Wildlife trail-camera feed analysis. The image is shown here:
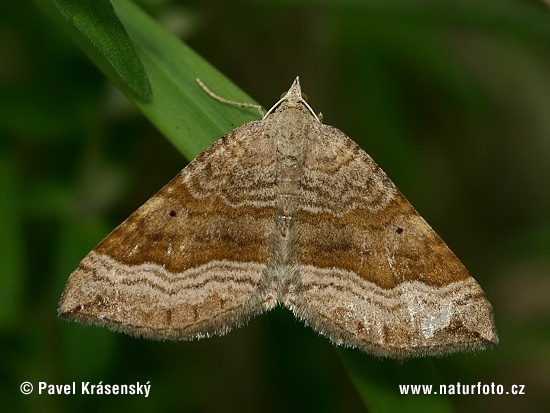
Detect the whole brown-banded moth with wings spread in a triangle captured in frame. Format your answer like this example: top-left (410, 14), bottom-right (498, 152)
top-left (59, 78), bottom-right (498, 358)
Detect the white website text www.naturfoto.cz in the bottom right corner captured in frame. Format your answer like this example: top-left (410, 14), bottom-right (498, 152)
top-left (399, 382), bottom-right (525, 395)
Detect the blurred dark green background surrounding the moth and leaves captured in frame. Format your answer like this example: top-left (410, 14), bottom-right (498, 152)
top-left (0, 0), bottom-right (550, 412)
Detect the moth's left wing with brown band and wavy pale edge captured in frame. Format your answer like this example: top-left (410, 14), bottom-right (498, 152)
top-left (59, 123), bottom-right (282, 339)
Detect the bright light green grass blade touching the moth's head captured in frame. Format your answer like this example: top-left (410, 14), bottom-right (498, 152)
top-left (112, 0), bottom-right (259, 159)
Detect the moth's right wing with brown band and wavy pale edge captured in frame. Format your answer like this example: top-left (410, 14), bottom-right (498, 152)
top-left (286, 126), bottom-right (497, 358)
